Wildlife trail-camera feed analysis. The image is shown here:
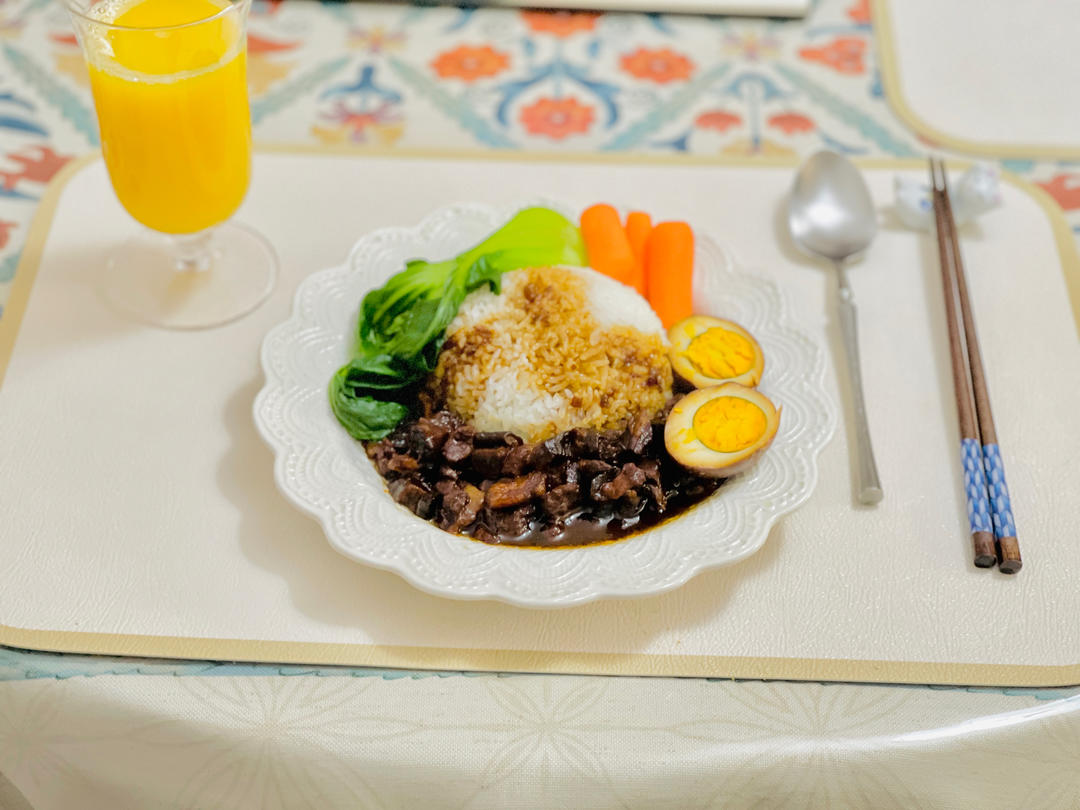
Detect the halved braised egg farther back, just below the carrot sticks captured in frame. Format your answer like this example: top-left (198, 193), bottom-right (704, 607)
top-left (667, 315), bottom-right (765, 388)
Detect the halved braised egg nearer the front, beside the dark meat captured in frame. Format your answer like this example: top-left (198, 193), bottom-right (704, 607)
top-left (664, 382), bottom-right (780, 478)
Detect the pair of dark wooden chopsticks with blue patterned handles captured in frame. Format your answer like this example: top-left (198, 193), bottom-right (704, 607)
top-left (930, 159), bottom-right (1023, 573)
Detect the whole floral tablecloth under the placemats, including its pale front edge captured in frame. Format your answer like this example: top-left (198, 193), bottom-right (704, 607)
top-left (0, 0), bottom-right (1080, 810)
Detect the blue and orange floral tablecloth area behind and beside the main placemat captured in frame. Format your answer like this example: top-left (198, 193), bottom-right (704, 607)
top-left (0, 0), bottom-right (1080, 306)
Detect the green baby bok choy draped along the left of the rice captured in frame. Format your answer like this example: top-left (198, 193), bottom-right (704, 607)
top-left (329, 207), bottom-right (585, 441)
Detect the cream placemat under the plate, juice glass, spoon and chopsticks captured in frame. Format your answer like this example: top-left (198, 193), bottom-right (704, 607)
top-left (0, 154), bottom-right (1080, 684)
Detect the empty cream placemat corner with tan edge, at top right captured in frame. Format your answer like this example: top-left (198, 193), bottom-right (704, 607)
top-left (874, 0), bottom-right (1080, 159)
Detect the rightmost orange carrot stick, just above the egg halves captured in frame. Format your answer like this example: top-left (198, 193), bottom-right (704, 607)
top-left (645, 222), bottom-right (693, 328)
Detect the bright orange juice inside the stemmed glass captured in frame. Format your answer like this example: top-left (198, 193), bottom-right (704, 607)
top-left (84, 0), bottom-right (252, 233)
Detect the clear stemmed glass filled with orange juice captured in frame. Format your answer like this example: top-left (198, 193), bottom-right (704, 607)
top-left (67, 0), bottom-right (278, 329)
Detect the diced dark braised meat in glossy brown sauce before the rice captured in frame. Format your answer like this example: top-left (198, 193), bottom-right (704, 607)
top-left (366, 410), bottom-right (723, 548)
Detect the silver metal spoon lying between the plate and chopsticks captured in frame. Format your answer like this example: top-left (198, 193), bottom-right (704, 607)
top-left (787, 151), bottom-right (882, 503)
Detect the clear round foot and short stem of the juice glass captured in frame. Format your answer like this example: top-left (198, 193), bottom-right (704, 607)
top-left (102, 222), bottom-right (278, 329)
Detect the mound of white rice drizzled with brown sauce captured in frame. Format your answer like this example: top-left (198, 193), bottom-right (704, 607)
top-left (428, 267), bottom-right (672, 442)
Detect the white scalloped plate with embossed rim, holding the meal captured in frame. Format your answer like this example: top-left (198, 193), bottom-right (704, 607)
top-left (255, 201), bottom-right (836, 607)
